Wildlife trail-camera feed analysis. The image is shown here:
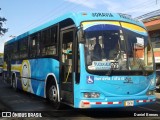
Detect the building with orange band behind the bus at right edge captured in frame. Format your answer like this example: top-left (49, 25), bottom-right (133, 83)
top-left (136, 9), bottom-right (160, 91)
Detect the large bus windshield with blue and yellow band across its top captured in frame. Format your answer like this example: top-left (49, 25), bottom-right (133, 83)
top-left (82, 21), bottom-right (153, 71)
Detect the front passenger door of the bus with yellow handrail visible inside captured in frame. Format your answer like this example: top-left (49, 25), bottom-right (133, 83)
top-left (60, 28), bottom-right (75, 104)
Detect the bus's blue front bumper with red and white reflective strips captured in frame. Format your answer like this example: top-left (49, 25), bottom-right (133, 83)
top-left (77, 95), bottom-right (156, 108)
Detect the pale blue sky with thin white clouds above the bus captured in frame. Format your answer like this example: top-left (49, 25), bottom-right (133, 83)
top-left (0, 0), bottom-right (160, 52)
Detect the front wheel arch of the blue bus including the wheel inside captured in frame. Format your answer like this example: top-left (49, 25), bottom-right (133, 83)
top-left (45, 75), bottom-right (61, 109)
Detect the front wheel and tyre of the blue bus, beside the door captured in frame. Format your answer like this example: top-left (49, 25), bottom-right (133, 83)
top-left (47, 80), bottom-right (62, 110)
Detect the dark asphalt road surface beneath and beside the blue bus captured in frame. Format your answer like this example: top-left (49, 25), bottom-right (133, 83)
top-left (0, 78), bottom-right (160, 120)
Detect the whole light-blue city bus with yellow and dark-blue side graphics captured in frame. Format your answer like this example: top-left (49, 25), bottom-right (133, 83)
top-left (3, 12), bottom-right (156, 109)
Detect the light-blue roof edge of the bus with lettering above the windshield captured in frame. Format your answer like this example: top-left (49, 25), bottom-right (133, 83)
top-left (5, 12), bottom-right (145, 45)
